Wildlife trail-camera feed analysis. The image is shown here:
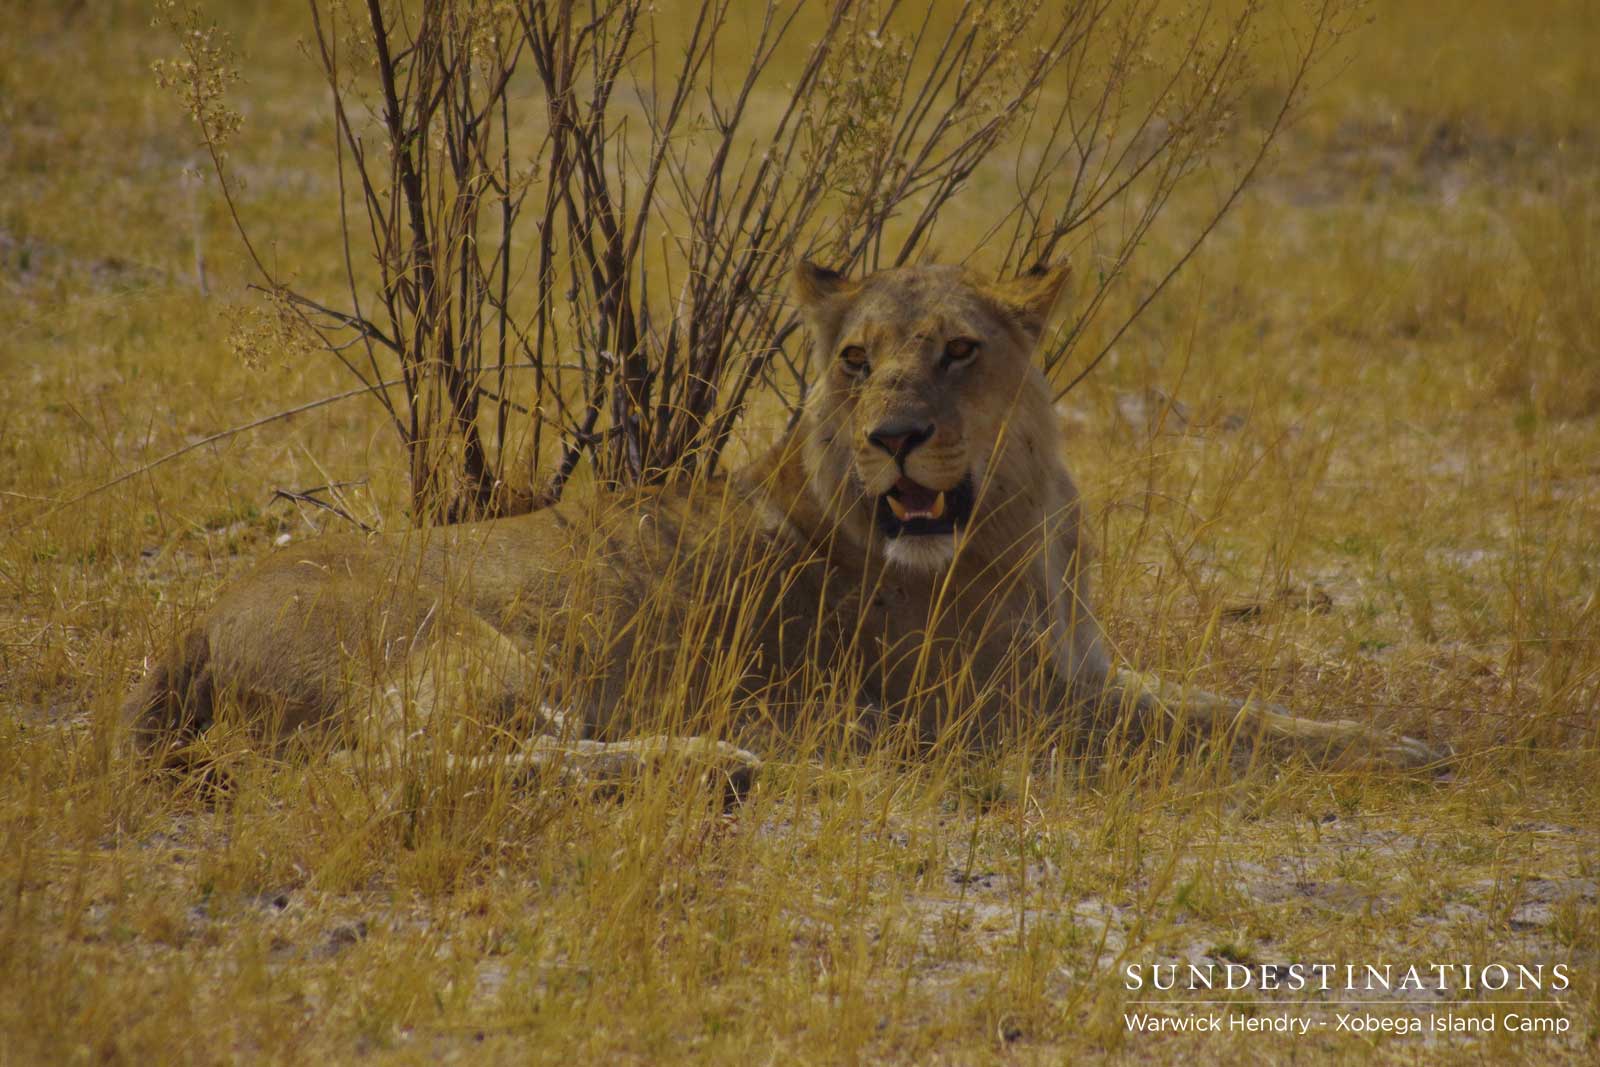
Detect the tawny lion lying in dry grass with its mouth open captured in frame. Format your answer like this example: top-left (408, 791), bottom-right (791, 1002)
top-left (126, 262), bottom-right (1437, 790)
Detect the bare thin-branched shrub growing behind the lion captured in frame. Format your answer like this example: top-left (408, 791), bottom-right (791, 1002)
top-left (158, 0), bottom-right (1352, 522)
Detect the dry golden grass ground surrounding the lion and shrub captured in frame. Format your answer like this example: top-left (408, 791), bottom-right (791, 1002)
top-left (0, 0), bottom-right (1600, 1064)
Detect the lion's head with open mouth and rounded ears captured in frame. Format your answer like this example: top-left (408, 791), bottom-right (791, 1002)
top-left (795, 262), bottom-right (1072, 571)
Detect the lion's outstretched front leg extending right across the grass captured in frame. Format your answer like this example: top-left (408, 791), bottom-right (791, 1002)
top-left (1115, 669), bottom-right (1450, 769)
